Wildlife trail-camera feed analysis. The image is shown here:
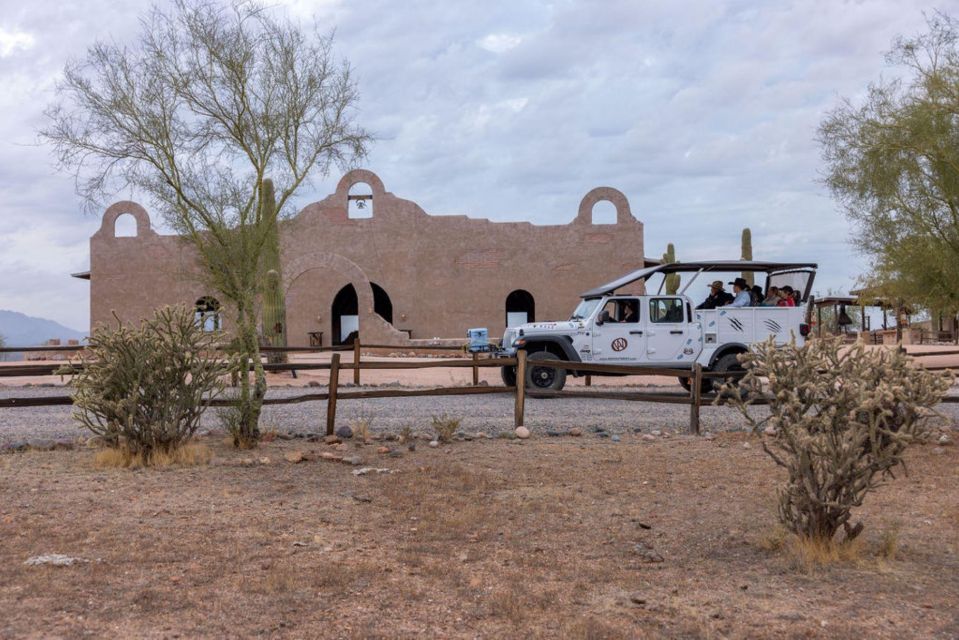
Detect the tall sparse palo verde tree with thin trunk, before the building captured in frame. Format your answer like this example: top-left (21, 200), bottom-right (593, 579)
top-left (41, 0), bottom-right (370, 447)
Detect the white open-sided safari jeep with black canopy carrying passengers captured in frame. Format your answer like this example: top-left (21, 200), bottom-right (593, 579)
top-left (500, 261), bottom-right (816, 391)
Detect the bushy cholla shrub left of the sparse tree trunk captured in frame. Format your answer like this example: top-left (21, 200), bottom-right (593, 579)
top-left (66, 307), bottom-right (229, 466)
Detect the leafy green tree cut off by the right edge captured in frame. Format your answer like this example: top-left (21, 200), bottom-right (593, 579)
top-left (819, 13), bottom-right (959, 322)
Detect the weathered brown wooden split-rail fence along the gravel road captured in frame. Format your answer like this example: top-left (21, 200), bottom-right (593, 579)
top-left (0, 340), bottom-right (959, 434)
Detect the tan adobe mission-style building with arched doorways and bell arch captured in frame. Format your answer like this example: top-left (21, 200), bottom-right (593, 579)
top-left (75, 169), bottom-right (650, 346)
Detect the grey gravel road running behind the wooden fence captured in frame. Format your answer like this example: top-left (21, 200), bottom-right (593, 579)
top-left (0, 387), bottom-right (959, 446)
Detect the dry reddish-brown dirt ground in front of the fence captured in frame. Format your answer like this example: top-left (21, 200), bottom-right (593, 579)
top-left (0, 434), bottom-right (959, 638)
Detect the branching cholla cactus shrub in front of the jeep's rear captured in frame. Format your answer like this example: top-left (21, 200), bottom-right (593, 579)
top-left (724, 338), bottom-right (952, 542)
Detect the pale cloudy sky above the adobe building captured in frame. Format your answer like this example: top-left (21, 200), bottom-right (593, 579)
top-left (0, 0), bottom-right (959, 329)
